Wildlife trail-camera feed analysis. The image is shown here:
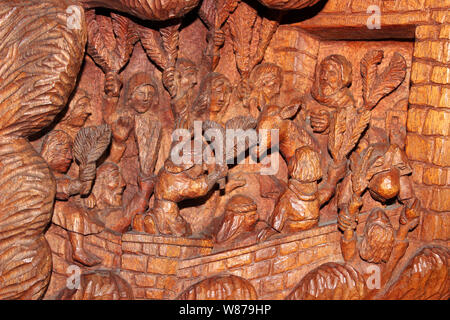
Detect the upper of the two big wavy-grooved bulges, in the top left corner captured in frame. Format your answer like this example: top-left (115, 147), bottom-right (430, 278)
top-left (0, 1), bottom-right (86, 137)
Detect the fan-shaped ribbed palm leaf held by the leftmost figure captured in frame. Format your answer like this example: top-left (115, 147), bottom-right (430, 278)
top-left (73, 124), bottom-right (111, 165)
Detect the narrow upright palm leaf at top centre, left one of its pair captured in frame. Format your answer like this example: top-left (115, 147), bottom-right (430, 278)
top-left (227, 3), bottom-right (257, 77)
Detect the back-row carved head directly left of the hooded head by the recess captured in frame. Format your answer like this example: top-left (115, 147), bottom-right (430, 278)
top-left (250, 63), bottom-right (283, 105)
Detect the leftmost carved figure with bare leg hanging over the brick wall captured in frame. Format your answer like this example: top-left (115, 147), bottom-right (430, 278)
top-left (41, 130), bottom-right (103, 266)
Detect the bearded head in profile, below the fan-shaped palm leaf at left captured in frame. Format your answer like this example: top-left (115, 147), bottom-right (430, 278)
top-left (92, 162), bottom-right (126, 209)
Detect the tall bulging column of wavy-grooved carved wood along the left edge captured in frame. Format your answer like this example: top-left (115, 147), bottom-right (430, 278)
top-left (0, 0), bottom-right (86, 299)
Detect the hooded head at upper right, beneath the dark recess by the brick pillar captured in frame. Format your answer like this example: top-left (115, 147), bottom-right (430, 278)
top-left (315, 54), bottom-right (352, 96)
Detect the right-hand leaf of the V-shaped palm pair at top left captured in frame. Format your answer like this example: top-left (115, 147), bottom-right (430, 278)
top-left (111, 13), bottom-right (139, 69)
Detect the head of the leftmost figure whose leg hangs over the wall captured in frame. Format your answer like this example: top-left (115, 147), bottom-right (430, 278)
top-left (41, 130), bottom-right (73, 170)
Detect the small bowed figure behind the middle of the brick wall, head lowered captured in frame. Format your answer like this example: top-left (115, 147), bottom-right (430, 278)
top-left (214, 195), bottom-right (267, 249)
